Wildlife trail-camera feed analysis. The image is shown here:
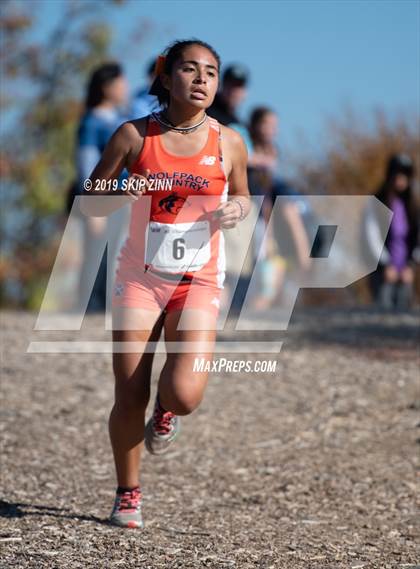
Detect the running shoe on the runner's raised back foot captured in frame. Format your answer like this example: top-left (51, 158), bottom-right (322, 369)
top-left (144, 398), bottom-right (181, 454)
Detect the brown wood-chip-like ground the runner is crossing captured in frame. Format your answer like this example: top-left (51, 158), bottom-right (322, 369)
top-left (0, 307), bottom-right (420, 569)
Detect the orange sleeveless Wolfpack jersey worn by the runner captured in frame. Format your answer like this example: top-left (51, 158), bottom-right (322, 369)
top-left (119, 114), bottom-right (228, 288)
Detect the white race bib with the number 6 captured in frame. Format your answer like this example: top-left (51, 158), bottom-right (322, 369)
top-left (144, 221), bottom-right (210, 273)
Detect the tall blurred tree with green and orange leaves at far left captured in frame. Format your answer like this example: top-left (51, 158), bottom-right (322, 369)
top-left (0, 0), bottom-right (150, 308)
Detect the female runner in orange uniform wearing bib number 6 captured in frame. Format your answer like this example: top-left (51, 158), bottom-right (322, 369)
top-left (81, 40), bottom-right (250, 527)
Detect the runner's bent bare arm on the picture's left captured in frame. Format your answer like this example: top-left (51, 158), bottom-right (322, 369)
top-left (80, 122), bottom-right (148, 217)
